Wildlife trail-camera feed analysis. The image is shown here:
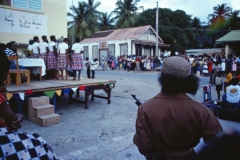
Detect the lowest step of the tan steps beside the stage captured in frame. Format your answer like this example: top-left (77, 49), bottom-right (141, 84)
top-left (37, 113), bottom-right (60, 126)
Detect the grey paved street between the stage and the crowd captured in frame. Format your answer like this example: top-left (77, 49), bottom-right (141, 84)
top-left (17, 70), bottom-right (240, 160)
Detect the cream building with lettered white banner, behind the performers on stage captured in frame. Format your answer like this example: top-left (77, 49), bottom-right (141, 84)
top-left (0, 0), bottom-right (67, 45)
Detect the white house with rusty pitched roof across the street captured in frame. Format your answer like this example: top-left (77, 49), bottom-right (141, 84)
top-left (80, 25), bottom-right (170, 63)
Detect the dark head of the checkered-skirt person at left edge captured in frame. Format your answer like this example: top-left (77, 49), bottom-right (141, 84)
top-left (0, 45), bottom-right (10, 86)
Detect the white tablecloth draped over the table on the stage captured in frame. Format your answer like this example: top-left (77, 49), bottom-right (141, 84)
top-left (18, 58), bottom-right (46, 76)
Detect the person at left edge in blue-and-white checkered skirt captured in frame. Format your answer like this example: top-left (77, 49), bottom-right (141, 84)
top-left (0, 44), bottom-right (57, 160)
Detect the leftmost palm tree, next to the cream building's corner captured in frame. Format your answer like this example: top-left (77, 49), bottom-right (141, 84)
top-left (67, 0), bottom-right (101, 39)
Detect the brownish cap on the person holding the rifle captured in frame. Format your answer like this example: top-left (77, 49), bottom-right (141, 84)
top-left (161, 56), bottom-right (191, 77)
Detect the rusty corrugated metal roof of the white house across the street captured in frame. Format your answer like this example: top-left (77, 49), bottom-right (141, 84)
top-left (80, 25), bottom-right (162, 43)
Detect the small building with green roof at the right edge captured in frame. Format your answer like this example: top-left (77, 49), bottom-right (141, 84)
top-left (216, 30), bottom-right (240, 57)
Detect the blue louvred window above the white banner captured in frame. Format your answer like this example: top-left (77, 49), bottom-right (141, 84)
top-left (12, 0), bottom-right (42, 11)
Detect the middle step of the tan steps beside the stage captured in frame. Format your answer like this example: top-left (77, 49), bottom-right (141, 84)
top-left (34, 104), bottom-right (54, 117)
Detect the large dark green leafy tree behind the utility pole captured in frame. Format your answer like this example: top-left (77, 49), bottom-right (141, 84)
top-left (136, 8), bottom-right (201, 52)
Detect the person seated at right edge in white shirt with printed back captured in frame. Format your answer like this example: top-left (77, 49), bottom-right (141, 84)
top-left (222, 78), bottom-right (240, 107)
